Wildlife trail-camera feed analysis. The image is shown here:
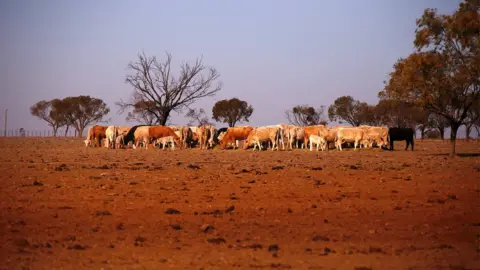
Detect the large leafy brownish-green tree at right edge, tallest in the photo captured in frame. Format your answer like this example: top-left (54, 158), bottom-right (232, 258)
top-left (379, 0), bottom-right (480, 155)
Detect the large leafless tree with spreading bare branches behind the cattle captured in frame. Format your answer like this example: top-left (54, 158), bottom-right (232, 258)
top-left (116, 53), bottom-right (222, 125)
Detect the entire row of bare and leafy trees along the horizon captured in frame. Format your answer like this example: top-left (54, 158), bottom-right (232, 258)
top-left (31, 0), bottom-right (480, 154)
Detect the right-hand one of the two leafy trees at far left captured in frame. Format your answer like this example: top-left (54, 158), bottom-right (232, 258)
top-left (61, 96), bottom-right (110, 137)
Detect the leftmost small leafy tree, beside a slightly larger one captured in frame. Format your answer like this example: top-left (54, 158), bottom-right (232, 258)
top-left (30, 99), bottom-right (66, 136)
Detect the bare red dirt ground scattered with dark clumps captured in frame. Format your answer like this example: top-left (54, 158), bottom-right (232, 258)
top-left (0, 138), bottom-right (480, 269)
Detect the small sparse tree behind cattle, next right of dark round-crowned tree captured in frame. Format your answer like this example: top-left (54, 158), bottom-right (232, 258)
top-left (285, 105), bottom-right (328, 126)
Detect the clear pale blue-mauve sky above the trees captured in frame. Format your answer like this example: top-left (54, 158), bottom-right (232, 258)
top-left (0, 0), bottom-right (460, 136)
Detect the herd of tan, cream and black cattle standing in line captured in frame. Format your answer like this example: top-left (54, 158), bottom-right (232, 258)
top-left (84, 124), bottom-right (414, 151)
